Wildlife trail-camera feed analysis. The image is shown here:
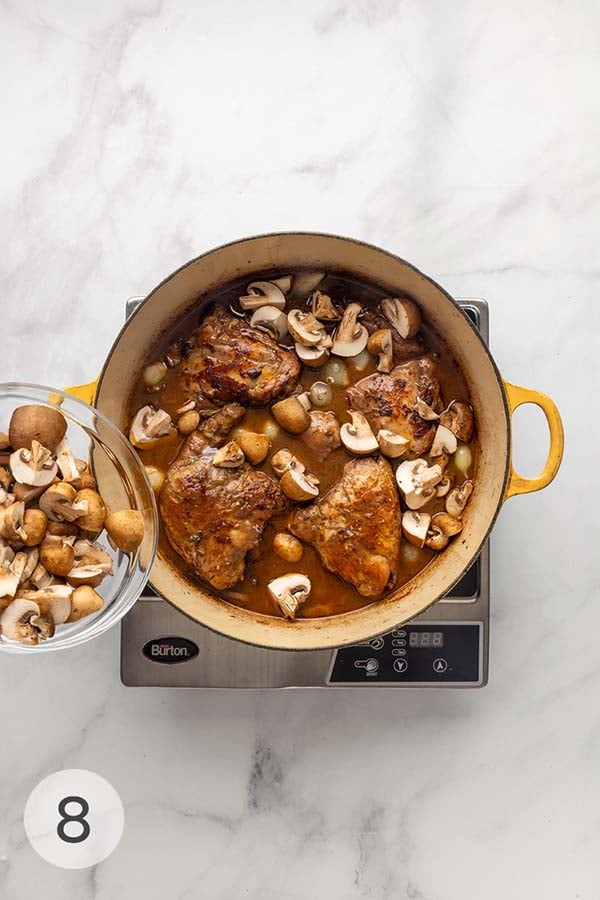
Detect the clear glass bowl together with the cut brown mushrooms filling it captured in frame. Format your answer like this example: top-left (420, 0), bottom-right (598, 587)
top-left (0, 382), bottom-right (158, 653)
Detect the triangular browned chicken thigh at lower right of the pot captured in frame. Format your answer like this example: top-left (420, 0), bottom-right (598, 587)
top-left (289, 457), bottom-right (402, 597)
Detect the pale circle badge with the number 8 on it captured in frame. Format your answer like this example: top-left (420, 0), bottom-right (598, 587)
top-left (23, 769), bottom-right (125, 869)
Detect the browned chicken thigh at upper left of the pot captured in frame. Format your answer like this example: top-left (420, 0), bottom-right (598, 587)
top-left (183, 306), bottom-right (301, 406)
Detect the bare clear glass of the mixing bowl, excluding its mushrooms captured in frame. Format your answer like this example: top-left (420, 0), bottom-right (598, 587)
top-left (0, 382), bottom-right (158, 653)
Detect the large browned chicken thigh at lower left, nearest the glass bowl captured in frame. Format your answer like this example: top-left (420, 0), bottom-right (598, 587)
top-left (160, 403), bottom-right (285, 590)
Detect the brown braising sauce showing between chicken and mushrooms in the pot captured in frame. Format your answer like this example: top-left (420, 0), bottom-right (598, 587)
top-left (130, 273), bottom-right (477, 618)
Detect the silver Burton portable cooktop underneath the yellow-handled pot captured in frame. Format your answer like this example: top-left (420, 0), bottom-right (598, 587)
top-left (121, 298), bottom-right (490, 688)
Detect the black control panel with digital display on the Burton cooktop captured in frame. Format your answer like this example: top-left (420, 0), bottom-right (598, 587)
top-left (326, 622), bottom-right (483, 687)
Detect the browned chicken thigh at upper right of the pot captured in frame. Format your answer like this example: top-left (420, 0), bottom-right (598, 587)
top-left (346, 356), bottom-right (442, 456)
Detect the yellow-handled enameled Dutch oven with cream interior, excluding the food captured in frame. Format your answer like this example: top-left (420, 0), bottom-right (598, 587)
top-left (71, 233), bottom-right (564, 650)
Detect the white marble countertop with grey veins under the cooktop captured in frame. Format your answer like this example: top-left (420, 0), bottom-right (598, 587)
top-left (0, 0), bottom-right (600, 900)
